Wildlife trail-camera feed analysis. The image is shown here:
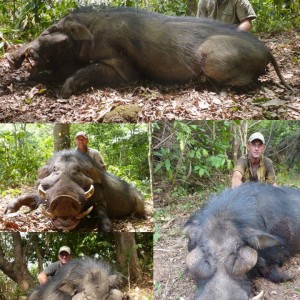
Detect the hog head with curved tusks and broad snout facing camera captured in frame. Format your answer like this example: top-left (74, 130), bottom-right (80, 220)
top-left (38, 152), bottom-right (101, 231)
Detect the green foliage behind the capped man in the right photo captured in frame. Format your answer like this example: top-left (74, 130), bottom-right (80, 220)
top-left (154, 120), bottom-right (300, 197)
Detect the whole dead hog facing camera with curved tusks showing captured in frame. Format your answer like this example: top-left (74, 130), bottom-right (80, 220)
top-left (5, 150), bottom-right (145, 231)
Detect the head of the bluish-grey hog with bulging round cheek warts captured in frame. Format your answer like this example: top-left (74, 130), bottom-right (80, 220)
top-left (186, 219), bottom-right (258, 300)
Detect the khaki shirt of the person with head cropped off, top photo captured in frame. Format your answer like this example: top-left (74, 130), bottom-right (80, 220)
top-left (197, 0), bottom-right (256, 24)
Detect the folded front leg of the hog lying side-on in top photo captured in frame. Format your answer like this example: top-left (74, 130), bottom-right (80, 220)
top-left (62, 59), bottom-right (138, 98)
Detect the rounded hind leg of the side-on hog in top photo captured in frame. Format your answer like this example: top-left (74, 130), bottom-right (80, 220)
top-left (197, 35), bottom-right (269, 86)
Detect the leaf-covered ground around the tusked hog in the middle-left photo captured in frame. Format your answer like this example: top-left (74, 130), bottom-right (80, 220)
top-left (0, 187), bottom-right (153, 232)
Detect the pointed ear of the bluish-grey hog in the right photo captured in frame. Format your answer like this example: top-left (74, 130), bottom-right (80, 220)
top-left (244, 228), bottom-right (284, 249)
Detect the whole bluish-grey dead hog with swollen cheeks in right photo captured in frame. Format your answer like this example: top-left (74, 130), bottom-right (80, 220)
top-left (185, 183), bottom-right (300, 300)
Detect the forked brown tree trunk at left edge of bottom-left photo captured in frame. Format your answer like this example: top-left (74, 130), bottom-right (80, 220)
top-left (0, 232), bottom-right (34, 291)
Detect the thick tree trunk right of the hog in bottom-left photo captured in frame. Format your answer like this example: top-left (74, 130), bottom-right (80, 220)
top-left (113, 232), bottom-right (141, 282)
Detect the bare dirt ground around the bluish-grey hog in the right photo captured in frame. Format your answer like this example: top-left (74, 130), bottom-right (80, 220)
top-left (154, 196), bottom-right (300, 300)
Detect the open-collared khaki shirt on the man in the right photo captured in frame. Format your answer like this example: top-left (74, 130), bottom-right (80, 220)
top-left (233, 155), bottom-right (275, 184)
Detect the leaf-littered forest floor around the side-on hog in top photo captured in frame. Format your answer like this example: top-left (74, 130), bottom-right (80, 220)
top-left (0, 30), bottom-right (300, 123)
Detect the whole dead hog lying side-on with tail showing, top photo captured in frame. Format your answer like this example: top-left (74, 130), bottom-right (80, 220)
top-left (7, 7), bottom-right (291, 98)
